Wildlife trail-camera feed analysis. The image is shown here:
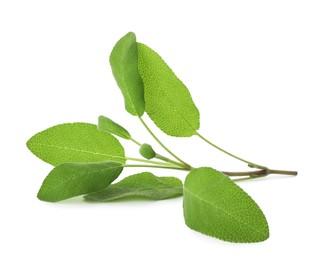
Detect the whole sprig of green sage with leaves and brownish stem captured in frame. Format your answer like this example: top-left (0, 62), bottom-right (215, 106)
top-left (27, 32), bottom-right (297, 243)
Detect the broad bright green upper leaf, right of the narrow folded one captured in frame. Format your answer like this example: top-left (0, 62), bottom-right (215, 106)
top-left (138, 43), bottom-right (200, 137)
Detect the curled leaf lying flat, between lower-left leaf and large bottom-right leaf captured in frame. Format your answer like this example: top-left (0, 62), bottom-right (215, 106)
top-left (84, 172), bottom-right (183, 201)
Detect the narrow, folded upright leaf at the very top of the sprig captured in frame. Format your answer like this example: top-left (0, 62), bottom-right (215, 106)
top-left (110, 32), bottom-right (145, 116)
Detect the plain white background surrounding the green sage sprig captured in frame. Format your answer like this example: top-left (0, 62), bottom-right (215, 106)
top-left (0, 0), bottom-right (323, 260)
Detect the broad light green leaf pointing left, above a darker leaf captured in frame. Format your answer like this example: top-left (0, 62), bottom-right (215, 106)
top-left (27, 123), bottom-right (125, 165)
